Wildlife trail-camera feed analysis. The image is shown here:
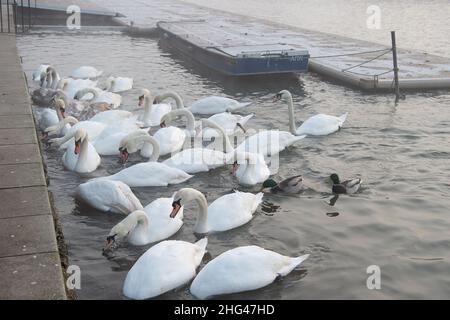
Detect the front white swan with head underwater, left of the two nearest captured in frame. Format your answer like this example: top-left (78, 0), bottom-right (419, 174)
top-left (123, 238), bottom-right (208, 299)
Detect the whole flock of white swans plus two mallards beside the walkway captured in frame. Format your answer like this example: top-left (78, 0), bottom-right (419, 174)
top-left (32, 65), bottom-right (361, 299)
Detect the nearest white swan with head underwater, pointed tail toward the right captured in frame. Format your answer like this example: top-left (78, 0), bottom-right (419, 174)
top-left (190, 246), bottom-right (309, 299)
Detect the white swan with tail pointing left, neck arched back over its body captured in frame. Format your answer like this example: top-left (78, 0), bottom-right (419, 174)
top-left (96, 134), bottom-right (192, 187)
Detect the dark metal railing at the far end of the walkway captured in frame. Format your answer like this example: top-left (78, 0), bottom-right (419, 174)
top-left (0, 0), bottom-right (32, 33)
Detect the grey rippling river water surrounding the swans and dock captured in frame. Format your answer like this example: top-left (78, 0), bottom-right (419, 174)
top-left (17, 0), bottom-right (450, 299)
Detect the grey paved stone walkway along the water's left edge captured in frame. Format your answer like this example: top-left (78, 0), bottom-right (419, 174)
top-left (0, 34), bottom-right (66, 299)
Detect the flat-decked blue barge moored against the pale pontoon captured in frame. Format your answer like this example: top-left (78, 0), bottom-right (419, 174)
top-left (157, 21), bottom-right (309, 76)
